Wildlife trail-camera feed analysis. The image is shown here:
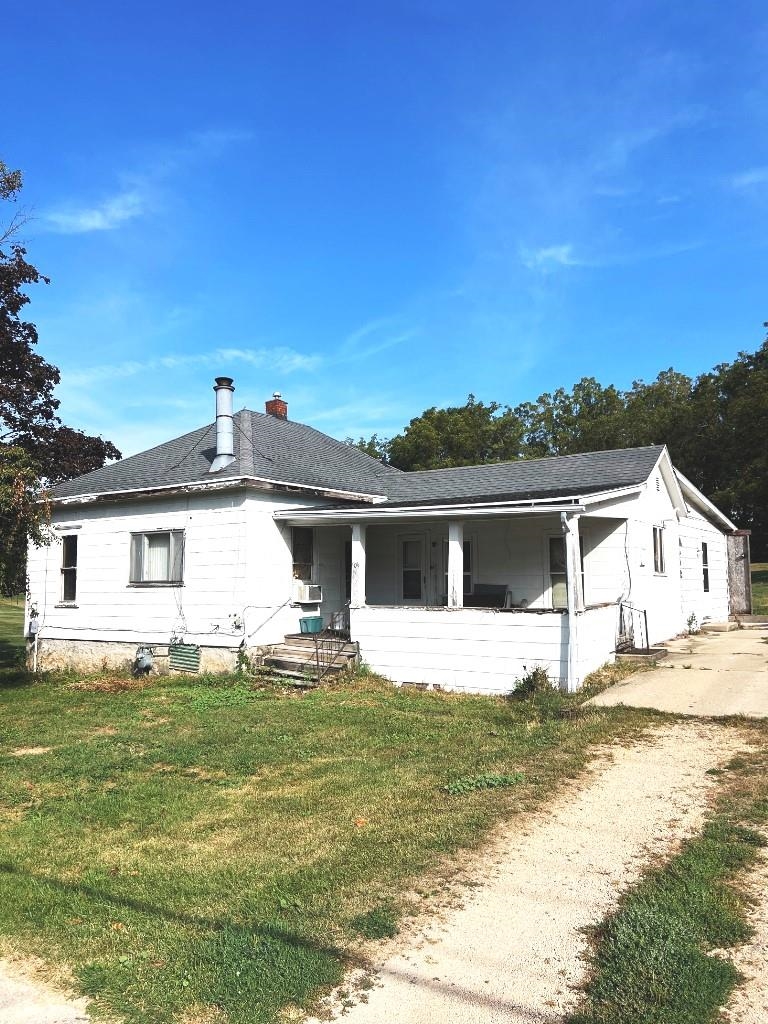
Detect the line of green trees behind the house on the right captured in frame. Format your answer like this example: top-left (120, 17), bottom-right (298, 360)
top-left (348, 344), bottom-right (768, 561)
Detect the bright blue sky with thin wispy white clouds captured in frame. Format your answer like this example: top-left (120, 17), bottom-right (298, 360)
top-left (6, 0), bottom-right (768, 454)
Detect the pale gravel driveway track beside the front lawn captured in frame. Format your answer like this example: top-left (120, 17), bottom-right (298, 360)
top-left (313, 722), bottom-right (749, 1024)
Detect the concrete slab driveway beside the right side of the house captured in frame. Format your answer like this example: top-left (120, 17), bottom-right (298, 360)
top-left (588, 629), bottom-right (768, 718)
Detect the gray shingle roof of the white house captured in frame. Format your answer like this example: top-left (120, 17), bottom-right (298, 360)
top-left (53, 410), bottom-right (664, 507)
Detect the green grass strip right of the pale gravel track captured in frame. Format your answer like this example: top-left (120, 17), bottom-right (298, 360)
top-left (567, 728), bottom-right (768, 1024)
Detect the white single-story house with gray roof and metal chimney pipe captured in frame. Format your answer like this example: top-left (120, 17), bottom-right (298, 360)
top-left (27, 377), bottom-right (736, 693)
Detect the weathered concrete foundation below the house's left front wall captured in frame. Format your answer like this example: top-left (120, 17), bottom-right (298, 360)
top-left (27, 639), bottom-right (241, 676)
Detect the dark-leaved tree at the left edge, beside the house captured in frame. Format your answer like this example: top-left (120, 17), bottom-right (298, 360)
top-left (0, 161), bottom-right (120, 592)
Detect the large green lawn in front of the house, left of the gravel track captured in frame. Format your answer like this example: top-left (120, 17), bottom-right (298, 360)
top-left (0, 651), bottom-right (652, 1024)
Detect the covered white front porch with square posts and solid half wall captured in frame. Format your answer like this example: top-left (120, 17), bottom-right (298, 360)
top-left (276, 504), bottom-right (621, 693)
